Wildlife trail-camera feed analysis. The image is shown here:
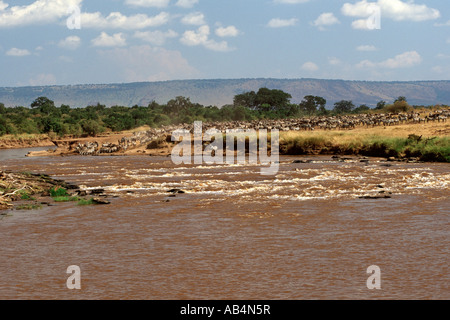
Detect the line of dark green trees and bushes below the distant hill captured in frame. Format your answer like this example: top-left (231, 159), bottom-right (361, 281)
top-left (0, 88), bottom-right (442, 137)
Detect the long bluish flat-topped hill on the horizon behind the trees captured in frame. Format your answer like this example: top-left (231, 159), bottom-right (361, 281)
top-left (0, 78), bottom-right (450, 108)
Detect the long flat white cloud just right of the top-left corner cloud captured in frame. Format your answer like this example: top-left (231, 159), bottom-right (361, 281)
top-left (81, 12), bottom-right (169, 30)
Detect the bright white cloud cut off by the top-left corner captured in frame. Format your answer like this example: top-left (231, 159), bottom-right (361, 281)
top-left (0, 0), bottom-right (83, 28)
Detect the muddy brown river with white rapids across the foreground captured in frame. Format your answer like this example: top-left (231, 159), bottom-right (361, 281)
top-left (0, 151), bottom-right (450, 300)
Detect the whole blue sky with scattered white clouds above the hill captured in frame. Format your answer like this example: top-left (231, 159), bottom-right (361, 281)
top-left (0, 0), bottom-right (450, 86)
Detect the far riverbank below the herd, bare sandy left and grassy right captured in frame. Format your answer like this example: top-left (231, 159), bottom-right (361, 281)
top-left (13, 122), bottom-right (450, 162)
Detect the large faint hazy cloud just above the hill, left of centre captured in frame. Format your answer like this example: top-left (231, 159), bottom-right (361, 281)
top-left (99, 45), bottom-right (199, 82)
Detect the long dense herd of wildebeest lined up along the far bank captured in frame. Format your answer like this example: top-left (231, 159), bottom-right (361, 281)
top-left (72, 108), bottom-right (450, 156)
